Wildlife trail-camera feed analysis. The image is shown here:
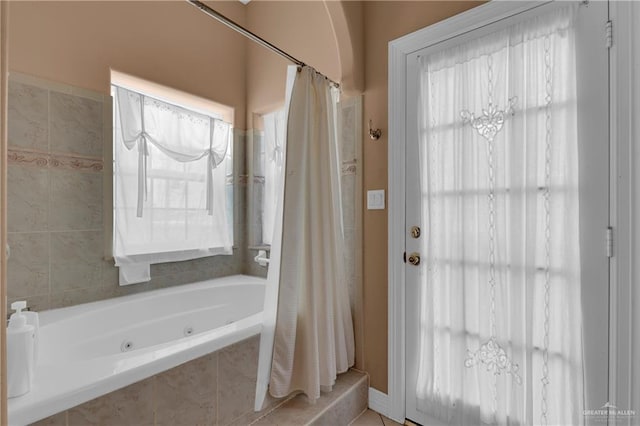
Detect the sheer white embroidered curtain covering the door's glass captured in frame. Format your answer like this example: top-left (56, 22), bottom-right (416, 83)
top-left (417, 7), bottom-right (582, 425)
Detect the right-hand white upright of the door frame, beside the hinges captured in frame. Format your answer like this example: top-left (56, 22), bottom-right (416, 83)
top-left (609, 1), bottom-right (640, 425)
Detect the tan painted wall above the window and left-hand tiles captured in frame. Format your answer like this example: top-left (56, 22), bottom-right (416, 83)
top-left (9, 1), bottom-right (246, 129)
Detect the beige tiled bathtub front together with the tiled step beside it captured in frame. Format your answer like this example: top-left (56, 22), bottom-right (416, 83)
top-left (33, 342), bottom-right (368, 426)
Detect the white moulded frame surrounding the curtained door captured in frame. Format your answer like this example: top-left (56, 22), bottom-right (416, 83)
top-left (384, 1), bottom-right (640, 423)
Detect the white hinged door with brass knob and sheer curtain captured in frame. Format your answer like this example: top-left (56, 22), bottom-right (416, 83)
top-left (405, 2), bottom-right (610, 425)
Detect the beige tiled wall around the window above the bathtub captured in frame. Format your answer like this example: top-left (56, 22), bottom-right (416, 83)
top-left (7, 73), bottom-right (247, 311)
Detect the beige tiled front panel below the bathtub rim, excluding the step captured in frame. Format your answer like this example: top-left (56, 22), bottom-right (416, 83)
top-left (34, 336), bottom-right (278, 426)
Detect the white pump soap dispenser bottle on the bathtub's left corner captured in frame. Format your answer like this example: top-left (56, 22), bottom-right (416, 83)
top-left (7, 301), bottom-right (35, 398)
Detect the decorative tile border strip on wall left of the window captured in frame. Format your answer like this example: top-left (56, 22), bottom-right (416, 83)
top-left (7, 148), bottom-right (104, 172)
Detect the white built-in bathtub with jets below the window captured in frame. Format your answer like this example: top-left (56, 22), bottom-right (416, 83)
top-left (8, 275), bottom-right (265, 425)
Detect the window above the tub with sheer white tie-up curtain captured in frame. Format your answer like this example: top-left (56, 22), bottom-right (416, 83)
top-left (112, 75), bottom-right (233, 285)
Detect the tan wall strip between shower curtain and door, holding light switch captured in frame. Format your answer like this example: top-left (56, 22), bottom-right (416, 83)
top-left (363, 1), bottom-right (480, 392)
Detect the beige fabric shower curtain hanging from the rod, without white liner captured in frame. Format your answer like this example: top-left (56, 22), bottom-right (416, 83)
top-left (269, 67), bottom-right (354, 401)
